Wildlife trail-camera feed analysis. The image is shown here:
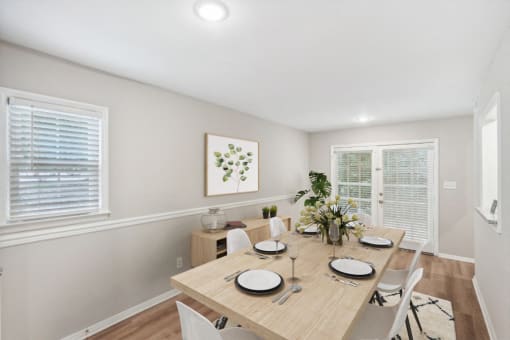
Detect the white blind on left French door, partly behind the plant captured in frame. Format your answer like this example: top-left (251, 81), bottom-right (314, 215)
top-left (336, 151), bottom-right (372, 216)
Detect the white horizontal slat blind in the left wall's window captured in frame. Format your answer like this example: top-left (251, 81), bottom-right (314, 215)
top-left (7, 97), bottom-right (102, 221)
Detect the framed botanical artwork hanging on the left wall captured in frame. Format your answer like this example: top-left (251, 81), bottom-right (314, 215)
top-left (205, 133), bottom-right (259, 196)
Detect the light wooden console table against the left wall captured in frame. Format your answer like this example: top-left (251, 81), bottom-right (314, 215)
top-left (191, 216), bottom-right (291, 267)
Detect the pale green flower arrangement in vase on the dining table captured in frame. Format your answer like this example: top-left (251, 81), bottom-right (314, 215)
top-left (296, 195), bottom-right (363, 245)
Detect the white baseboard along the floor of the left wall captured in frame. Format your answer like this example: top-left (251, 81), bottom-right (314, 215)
top-left (61, 289), bottom-right (180, 340)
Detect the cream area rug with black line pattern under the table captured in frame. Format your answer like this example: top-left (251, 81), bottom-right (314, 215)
top-left (383, 292), bottom-right (455, 340)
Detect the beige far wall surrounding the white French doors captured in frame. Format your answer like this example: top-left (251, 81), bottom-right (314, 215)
top-left (309, 116), bottom-right (473, 258)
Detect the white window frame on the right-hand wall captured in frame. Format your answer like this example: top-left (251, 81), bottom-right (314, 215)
top-left (475, 92), bottom-right (503, 234)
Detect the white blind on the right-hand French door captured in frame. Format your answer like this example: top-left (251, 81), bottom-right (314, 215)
top-left (383, 147), bottom-right (434, 241)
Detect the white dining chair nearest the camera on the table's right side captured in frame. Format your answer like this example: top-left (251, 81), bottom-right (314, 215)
top-left (351, 268), bottom-right (423, 340)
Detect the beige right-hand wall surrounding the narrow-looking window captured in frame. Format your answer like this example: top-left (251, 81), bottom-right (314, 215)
top-left (474, 30), bottom-right (510, 339)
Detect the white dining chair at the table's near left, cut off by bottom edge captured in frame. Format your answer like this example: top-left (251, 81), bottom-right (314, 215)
top-left (176, 301), bottom-right (262, 340)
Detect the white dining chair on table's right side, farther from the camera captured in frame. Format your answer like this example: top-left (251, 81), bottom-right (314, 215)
top-left (376, 242), bottom-right (426, 332)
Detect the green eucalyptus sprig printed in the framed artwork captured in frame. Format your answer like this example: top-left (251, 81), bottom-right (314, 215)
top-left (214, 144), bottom-right (253, 192)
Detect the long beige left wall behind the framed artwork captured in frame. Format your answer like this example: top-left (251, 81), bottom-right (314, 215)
top-left (0, 43), bottom-right (308, 340)
